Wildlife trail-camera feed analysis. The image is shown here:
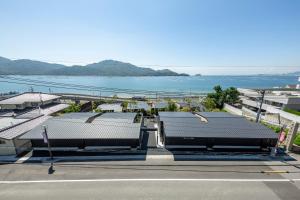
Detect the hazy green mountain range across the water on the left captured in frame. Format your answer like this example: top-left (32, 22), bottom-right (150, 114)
top-left (0, 57), bottom-right (189, 76)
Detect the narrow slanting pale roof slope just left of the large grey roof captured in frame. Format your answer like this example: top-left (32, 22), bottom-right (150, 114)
top-left (0, 116), bottom-right (51, 140)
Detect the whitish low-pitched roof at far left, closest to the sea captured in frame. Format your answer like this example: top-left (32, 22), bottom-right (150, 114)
top-left (0, 93), bottom-right (60, 105)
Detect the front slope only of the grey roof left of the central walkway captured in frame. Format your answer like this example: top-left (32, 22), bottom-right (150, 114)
top-left (21, 118), bottom-right (140, 139)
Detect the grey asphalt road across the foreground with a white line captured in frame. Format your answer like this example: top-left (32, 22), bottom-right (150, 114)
top-left (0, 161), bottom-right (300, 200)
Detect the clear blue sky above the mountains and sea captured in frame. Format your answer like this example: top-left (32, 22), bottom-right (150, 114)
top-left (0, 0), bottom-right (300, 74)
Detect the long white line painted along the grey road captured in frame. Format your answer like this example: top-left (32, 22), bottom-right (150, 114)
top-left (0, 178), bottom-right (300, 184)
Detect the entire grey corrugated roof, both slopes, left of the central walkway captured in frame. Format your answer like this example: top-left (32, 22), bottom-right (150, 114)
top-left (21, 113), bottom-right (141, 140)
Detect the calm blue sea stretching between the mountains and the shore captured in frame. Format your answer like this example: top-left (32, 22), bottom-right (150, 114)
top-left (0, 76), bottom-right (298, 95)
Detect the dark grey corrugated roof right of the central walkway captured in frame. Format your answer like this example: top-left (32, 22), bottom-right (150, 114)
top-left (159, 112), bottom-right (277, 138)
